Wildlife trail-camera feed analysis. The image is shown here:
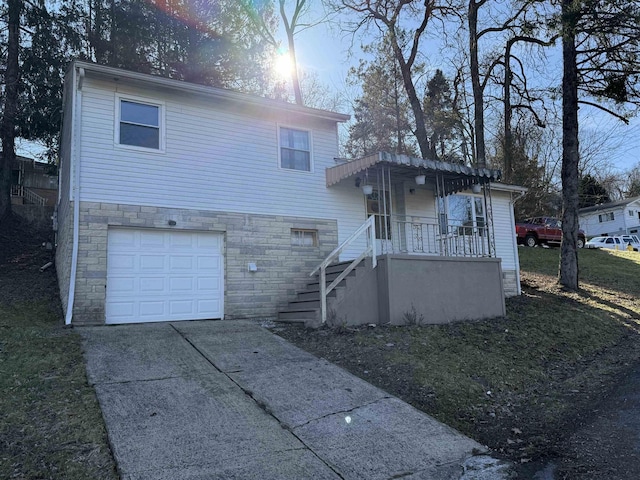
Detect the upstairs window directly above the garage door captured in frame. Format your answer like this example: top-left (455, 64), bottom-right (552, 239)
top-left (118, 99), bottom-right (160, 150)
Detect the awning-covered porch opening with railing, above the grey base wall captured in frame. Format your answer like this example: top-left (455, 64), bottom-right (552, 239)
top-left (326, 153), bottom-right (500, 258)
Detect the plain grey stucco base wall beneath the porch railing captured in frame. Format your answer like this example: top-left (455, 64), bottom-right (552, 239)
top-left (377, 255), bottom-right (505, 325)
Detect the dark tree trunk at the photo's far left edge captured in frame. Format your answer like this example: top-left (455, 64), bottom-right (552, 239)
top-left (0, 0), bottom-right (23, 220)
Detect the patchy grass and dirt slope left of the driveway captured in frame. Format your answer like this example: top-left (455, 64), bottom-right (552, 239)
top-left (0, 216), bottom-right (117, 480)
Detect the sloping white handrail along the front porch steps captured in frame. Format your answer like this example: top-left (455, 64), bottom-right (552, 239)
top-left (309, 216), bottom-right (378, 323)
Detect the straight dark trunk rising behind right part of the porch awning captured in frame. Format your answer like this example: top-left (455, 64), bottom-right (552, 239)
top-left (468, 0), bottom-right (487, 168)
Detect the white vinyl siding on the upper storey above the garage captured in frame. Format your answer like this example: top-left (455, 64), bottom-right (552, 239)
top-left (75, 77), bottom-right (365, 258)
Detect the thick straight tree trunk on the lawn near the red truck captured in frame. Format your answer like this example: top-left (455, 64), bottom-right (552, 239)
top-left (558, 0), bottom-right (578, 290)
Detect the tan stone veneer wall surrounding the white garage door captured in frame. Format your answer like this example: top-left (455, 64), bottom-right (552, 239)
top-left (69, 202), bottom-right (338, 325)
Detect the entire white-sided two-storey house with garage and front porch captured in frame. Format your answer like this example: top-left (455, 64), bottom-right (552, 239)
top-left (56, 62), bottom-right (523, 324)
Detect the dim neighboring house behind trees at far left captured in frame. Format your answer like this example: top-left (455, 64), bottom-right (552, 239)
top-left (5, 153), bottom-right (58, 206)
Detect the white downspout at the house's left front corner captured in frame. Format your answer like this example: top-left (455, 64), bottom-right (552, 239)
top-left (64, 68), bottom-right (84, 326)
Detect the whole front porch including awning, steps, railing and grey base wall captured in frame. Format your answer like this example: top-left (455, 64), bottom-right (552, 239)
top-left (279, 153), bottom-right (505, 326)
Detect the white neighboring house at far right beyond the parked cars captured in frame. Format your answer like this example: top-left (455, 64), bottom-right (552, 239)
top-left (578, 197), bottom-right (640, 237)
